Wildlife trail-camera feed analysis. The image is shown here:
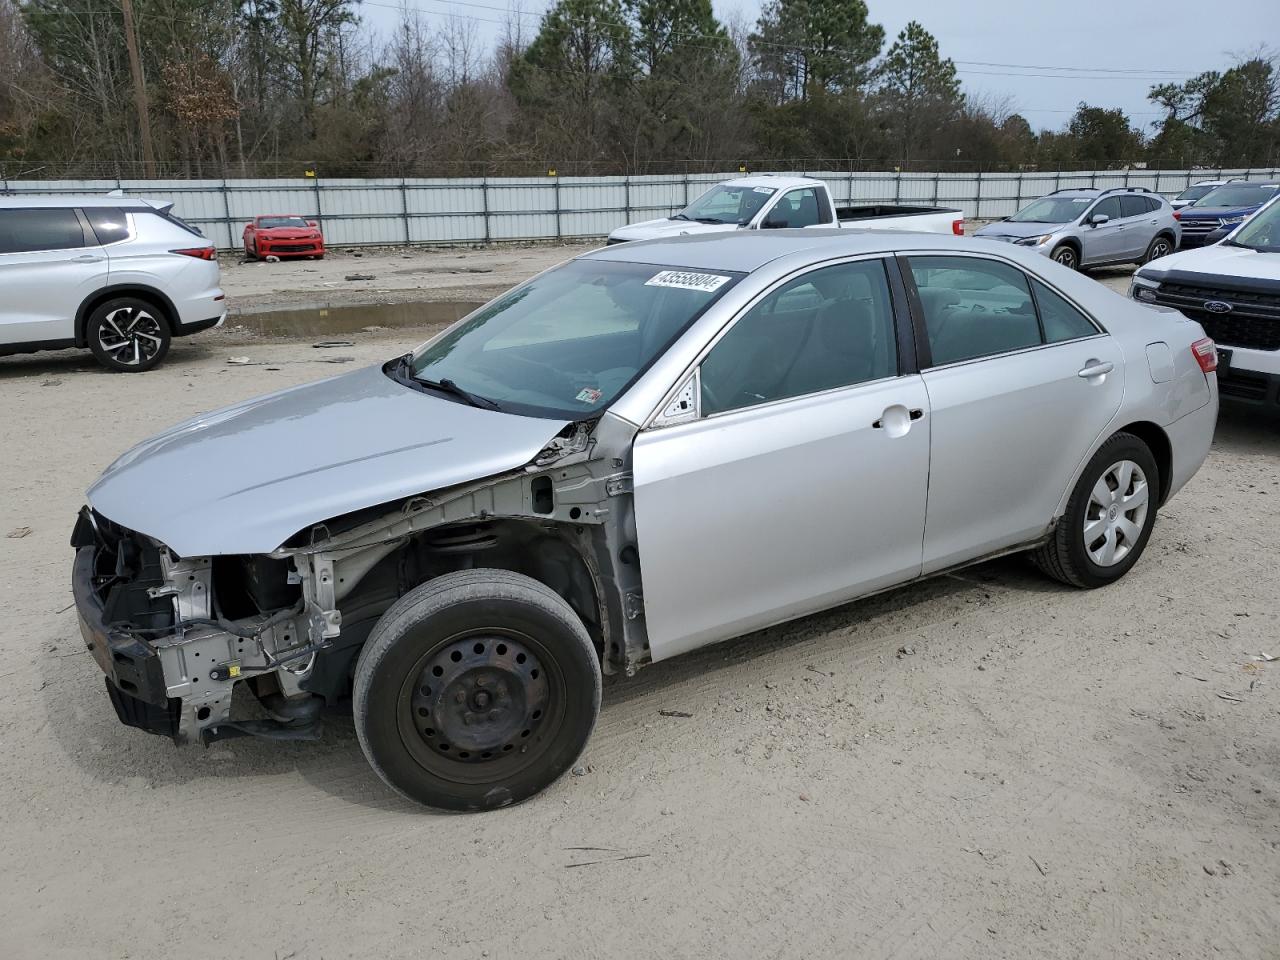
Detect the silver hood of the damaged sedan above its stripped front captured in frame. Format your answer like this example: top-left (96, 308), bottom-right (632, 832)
top-left (88, 366), bottom-right (567, 557)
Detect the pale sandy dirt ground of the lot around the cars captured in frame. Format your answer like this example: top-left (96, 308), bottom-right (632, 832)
top-left (0, 251), bottom-right (1280, 960)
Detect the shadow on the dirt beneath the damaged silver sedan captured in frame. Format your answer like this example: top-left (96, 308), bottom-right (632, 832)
top-left (40, 557), bottom-right (1068, 814)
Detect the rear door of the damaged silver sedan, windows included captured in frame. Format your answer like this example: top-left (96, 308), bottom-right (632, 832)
top-left (906, 255), bottom-right (1124, 573)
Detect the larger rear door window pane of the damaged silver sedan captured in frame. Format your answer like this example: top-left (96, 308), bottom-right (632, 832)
top-left (910, 257), bottom-right (1041, 366)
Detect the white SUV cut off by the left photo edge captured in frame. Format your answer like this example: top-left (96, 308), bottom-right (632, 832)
top-left (0, 196), bottom-right (227, 371)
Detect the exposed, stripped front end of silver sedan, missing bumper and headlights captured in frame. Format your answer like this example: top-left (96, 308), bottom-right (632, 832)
top-left (72, 507), bottom-right (340, 744)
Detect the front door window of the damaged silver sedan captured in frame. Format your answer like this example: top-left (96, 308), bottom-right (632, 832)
top-left (700, 260), bottom-right (897, 416)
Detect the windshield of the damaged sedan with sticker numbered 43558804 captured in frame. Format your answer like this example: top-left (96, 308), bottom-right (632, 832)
top-left (403, 260), bottom-right (742, 420)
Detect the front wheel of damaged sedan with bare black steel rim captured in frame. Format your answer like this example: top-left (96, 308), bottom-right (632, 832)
top-left (353, 570), bottom-right (600, 810)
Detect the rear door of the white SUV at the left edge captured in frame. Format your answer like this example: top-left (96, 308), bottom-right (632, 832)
top-left (0, 207), bottom-right (108, 343)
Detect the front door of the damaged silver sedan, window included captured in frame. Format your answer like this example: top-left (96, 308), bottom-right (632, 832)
top-left (632, 260), bottom-right (929, 660)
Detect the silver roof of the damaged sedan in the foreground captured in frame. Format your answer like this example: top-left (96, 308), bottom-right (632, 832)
top-left (577, 229), bottom-right (1009, 273)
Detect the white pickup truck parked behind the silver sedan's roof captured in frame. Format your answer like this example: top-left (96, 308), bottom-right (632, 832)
top-left (609, 174), bottom-right (964, 243)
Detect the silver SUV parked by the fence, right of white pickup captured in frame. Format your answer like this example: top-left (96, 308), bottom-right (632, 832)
top-left (975, 187), bottom-right (1181, 270)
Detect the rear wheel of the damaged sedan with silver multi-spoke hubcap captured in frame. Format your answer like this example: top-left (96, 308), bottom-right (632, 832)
top-left (1032, 433), bottom-right (1160, 589)
